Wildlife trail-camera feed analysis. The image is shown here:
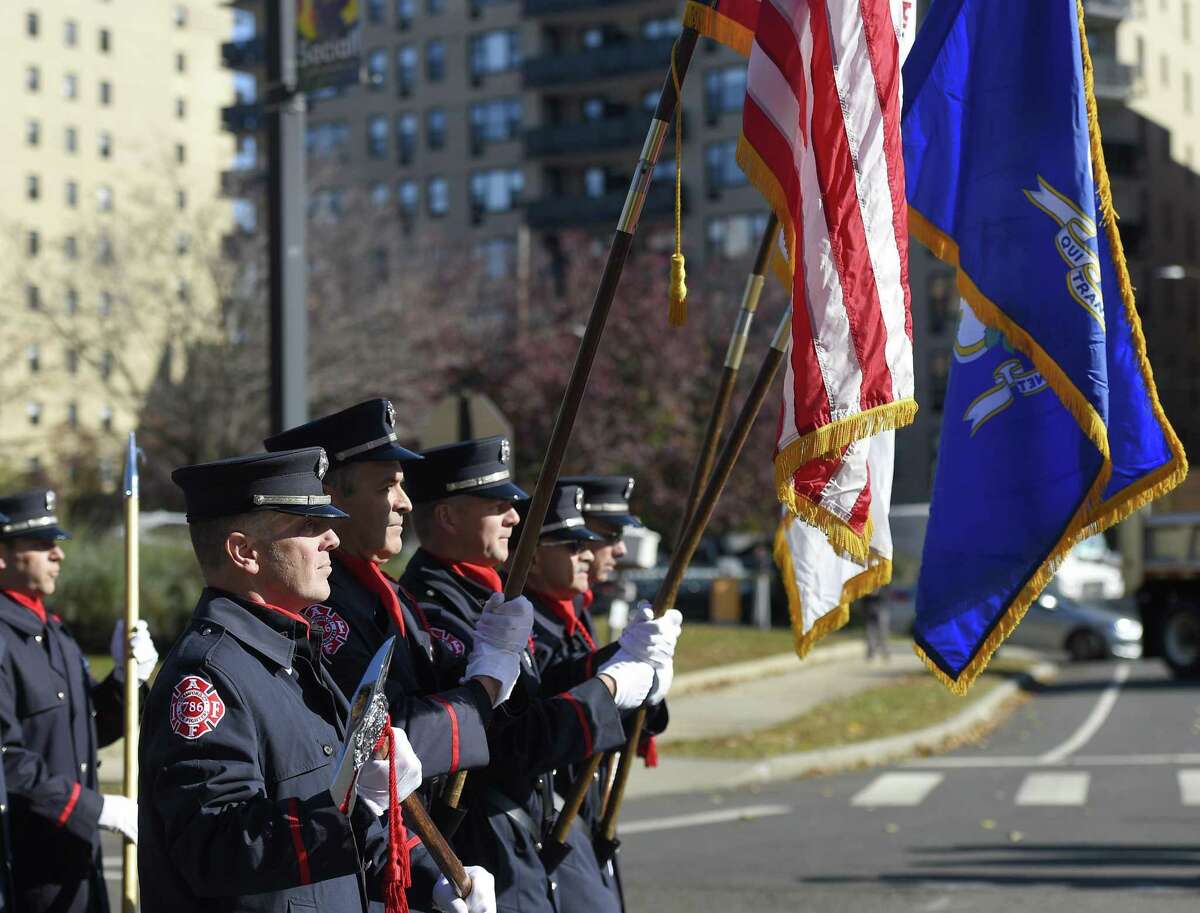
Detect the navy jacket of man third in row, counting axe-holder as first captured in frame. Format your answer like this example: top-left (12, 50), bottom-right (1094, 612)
top-left (401, 549), bottom-right (625, 913)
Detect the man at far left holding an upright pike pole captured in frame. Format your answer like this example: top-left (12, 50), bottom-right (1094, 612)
top-left (0, 489), bottom-right (158, 913)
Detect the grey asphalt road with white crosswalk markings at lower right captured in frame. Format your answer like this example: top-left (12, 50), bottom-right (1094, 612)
top-left (622, 662), bottom-right (1200, 913)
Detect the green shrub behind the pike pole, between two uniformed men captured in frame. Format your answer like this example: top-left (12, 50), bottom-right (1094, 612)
top-left (47, 533), bottom-right (203, 654)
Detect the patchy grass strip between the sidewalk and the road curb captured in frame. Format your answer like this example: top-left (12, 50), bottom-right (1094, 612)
top-left (660, 659), bottom-right (1033, 761)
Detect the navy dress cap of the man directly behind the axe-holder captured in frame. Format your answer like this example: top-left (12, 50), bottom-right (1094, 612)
top-left (263, 400), bottom-right (421, 467)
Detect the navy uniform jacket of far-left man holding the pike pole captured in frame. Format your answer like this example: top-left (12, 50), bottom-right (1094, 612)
top-left (0, 593), bottom-right (124, 913)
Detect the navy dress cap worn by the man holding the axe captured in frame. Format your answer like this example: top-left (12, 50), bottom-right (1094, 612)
top-left (170, 448), bottom-right (349, 523)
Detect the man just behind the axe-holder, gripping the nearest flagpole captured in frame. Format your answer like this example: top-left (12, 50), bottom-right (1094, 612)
top-left (265, 400), bottom-right (533, 777)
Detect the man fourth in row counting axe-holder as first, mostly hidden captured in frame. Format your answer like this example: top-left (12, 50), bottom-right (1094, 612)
top-left (524, 482), bottom-right (678, 911)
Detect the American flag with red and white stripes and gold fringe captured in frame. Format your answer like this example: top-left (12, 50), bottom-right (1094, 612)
top-left (685, 0), bottom-right (917, 564)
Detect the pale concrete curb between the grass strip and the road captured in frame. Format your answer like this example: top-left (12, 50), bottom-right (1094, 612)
top-left (630, 644), bottom-right (1058, 799)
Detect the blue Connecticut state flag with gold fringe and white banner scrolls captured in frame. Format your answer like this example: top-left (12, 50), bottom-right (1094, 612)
top-left (901, 0), bottom-right (1187, 693)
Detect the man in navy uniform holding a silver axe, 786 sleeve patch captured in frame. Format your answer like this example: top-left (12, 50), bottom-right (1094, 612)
top-left (138, 448), bottom-right (453, 913)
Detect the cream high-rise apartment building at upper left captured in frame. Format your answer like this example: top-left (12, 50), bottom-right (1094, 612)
top-left (0, 0), bottom-right (233, 482)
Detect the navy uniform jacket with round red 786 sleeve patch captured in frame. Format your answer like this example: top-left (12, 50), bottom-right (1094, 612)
top-left (138, 589), bottom-right (396, 913)
